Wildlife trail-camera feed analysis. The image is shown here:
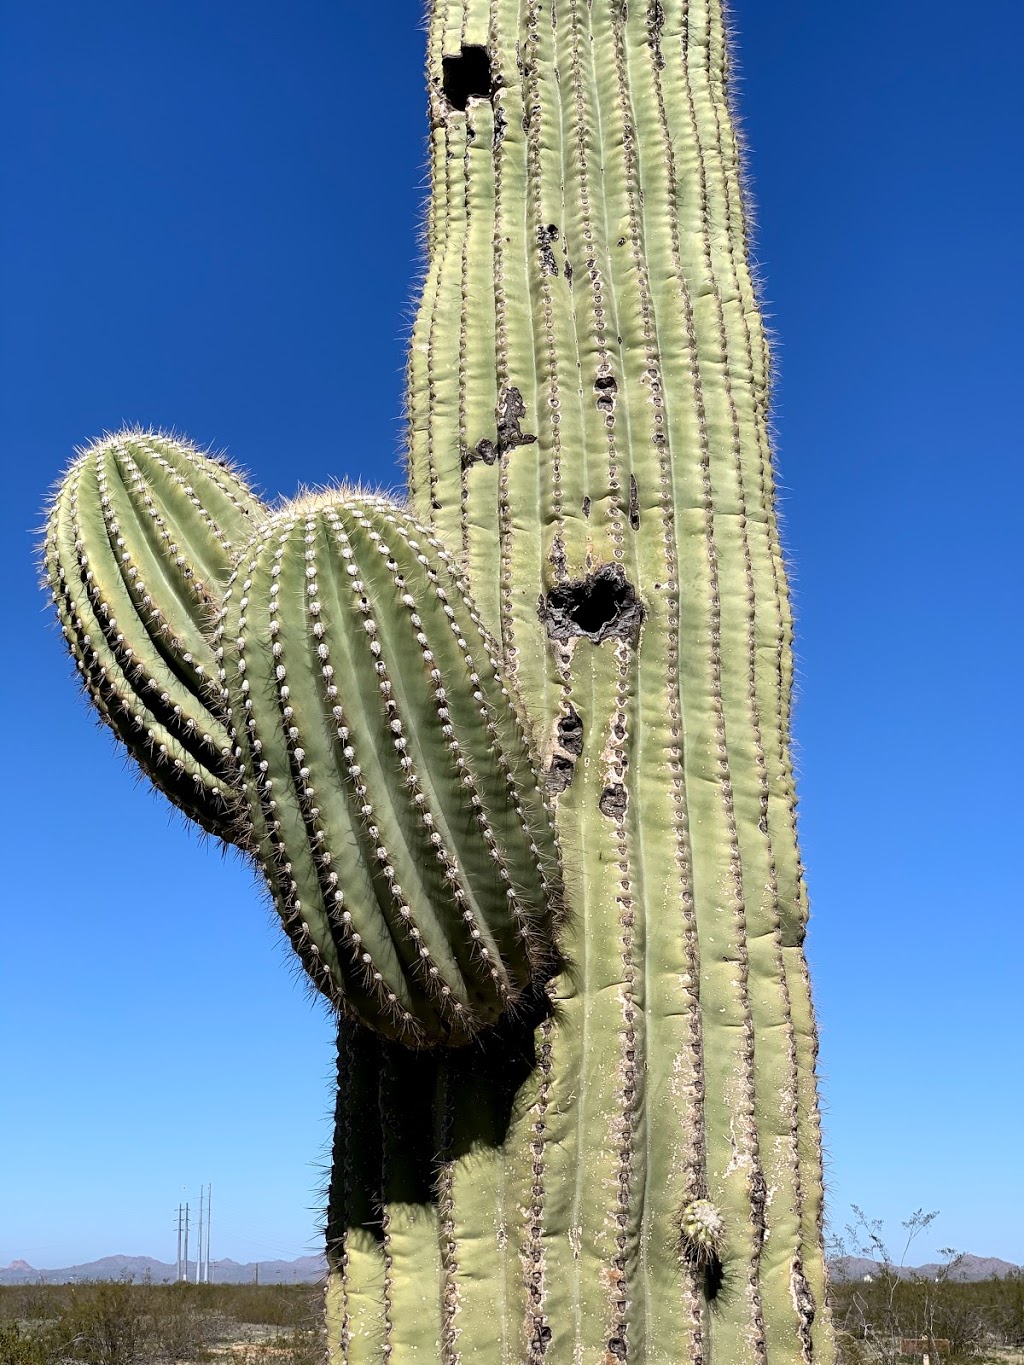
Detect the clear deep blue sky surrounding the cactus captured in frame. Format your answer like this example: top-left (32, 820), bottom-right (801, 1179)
top-left (0, 0), bottom-right (1024, 1267)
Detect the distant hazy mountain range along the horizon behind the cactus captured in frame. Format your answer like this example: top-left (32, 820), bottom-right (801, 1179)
top-left (0, 1256), bottom-right (1024, 1284)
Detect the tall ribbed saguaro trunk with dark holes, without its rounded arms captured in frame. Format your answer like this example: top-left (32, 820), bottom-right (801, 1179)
top-left (328, 0), bottom-right (831, 1365)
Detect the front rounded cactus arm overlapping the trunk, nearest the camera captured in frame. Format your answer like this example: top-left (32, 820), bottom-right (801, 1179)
top-left (218, 493), bottom-right (561, 1047)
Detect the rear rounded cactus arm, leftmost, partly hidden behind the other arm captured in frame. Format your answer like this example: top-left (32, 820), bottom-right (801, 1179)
top-left (42, 431), bottom-right (266, 842)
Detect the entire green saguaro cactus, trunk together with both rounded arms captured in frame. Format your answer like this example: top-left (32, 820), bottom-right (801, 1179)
top-left (46, 0), bottom-right (834, 1365)
